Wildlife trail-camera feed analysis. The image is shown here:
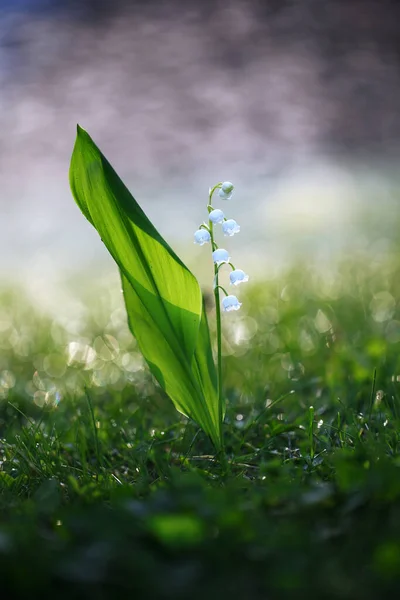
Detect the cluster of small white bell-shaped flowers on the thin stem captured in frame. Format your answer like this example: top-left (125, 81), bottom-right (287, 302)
top-left (194, 181), bottom-right (249, 312)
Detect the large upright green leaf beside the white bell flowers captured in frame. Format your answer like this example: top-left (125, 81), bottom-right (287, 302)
top-left (70, 126), bottom-right (221, 448)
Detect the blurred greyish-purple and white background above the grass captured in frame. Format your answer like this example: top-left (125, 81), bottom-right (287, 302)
top-left (0, 0), bottom-right (400, 304)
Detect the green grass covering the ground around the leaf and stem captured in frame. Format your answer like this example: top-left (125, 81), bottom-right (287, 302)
top-left (0, 247), bottom-right (400, 600)
